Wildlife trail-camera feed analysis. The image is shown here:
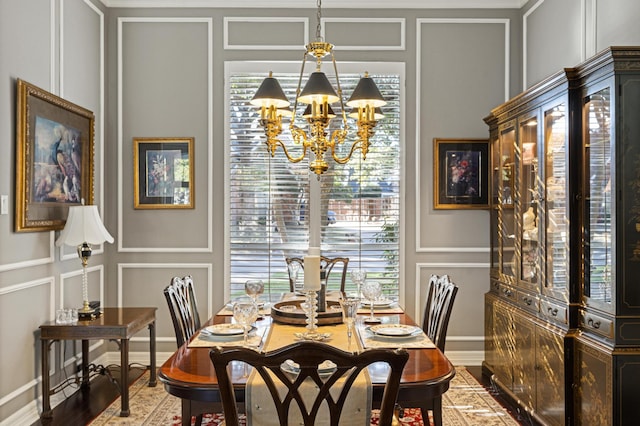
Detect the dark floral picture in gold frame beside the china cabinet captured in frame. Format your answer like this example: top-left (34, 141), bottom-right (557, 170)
top-left (433, 138), bottom-right (489, 210)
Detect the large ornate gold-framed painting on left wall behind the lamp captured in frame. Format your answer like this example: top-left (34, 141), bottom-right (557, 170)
top-left (14, 79), bottom-right (95, 232)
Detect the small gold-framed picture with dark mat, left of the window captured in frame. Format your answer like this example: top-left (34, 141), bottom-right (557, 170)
top-left (133, 137), bottom-right (195, 209)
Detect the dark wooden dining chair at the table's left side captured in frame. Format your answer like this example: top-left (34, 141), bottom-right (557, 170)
top-left (164, 275), bottom-right (200, 348)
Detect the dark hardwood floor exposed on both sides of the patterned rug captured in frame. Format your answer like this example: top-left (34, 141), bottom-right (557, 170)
top-left (32, 366), bottom-right (538, 426)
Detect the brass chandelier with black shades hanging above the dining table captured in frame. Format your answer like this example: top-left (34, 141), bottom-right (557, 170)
top-left (251, 0), bottom-right (387, 179)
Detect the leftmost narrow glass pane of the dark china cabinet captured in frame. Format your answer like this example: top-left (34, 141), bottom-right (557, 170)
top-left (498, 127), bottom-right (516, 278)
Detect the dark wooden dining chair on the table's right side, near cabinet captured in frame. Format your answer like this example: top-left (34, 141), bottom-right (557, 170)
top-left (422, 275), bottom-right (458, 425)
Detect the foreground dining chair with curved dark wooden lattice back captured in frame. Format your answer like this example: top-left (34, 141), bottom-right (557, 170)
top-left (209, 341), bottom-right (409, 426)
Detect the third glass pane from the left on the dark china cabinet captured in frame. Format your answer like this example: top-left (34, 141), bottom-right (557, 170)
top-left (540, 103), bottom-right (569, 300)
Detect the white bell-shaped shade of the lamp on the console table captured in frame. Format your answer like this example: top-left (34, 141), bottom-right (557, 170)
top-left (56, 206), bottom-right (113, 246)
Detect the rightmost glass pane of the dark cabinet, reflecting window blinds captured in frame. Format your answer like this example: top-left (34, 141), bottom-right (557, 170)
top-left (583, 87), bottom-right (615, 311)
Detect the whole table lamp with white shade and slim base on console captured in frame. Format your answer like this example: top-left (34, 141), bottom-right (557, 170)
top-left (56, 206), bottom-right (113, 318)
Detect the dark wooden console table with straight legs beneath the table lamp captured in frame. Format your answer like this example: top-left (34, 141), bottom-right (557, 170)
top-left (40, 308), bottom-right (157, 418)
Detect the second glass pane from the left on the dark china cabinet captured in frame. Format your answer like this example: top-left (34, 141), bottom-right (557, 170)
top-left (517, 117), bottom-right (540, 284)
